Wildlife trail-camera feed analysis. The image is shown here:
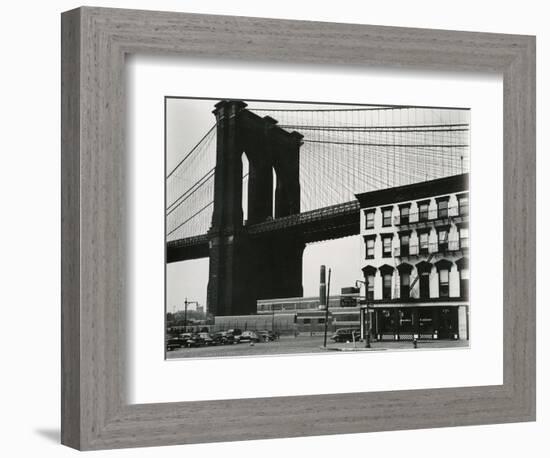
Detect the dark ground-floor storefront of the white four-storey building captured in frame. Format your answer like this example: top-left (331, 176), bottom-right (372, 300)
top-left (372, 305), bottom-right (468, 340)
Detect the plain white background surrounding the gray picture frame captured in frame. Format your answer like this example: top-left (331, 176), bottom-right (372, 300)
top-left (0, 0), bottom-right (550, 458)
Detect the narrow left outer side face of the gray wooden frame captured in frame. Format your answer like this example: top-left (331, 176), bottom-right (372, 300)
top-left (61, 11), bottom-right (81, 447)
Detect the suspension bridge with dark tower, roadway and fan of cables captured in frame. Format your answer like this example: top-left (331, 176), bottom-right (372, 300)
top-left (166, 100), bottom-right (469, 315)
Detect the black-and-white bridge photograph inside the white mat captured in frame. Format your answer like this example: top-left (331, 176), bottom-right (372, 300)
top-left (165, 96), bottom-right (475, 359)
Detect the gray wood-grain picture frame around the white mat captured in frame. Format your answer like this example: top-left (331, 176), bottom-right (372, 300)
top-left (61, 7), bottom-right (536, 450)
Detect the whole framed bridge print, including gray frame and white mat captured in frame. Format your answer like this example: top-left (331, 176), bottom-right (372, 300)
top-left (62, 7), bottom-right (535, 450)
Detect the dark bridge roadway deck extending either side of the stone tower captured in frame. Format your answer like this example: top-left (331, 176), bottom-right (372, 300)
top-left (166, 200), bottom-right (359, 263)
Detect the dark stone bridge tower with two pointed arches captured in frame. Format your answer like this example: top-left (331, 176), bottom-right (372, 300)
top-left (207, 100), bottom-right (305, 315)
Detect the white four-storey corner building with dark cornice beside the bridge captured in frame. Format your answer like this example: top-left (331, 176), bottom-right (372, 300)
top-left (356, 174), bottom-right (470, 340)
